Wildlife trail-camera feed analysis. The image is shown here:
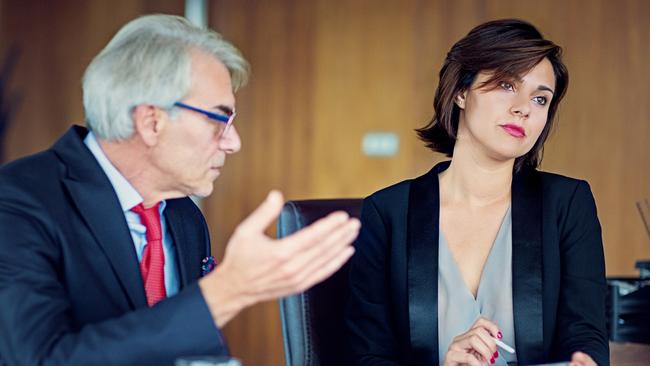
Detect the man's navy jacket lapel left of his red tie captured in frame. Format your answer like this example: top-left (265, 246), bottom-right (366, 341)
top-left (53, 127), bottom-right (147, 308)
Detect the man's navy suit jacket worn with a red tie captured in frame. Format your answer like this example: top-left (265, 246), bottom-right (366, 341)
top-left (0, 126), bottom-right (227, 365)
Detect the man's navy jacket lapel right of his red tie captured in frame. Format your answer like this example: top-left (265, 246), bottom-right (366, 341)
top-left (165, 200), bottom-right (201, 288)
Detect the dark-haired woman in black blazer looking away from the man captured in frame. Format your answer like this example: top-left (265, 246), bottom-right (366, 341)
top-left (346, 20), bottom-right (609, 365)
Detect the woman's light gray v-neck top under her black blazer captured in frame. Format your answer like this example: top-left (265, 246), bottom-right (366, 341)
top-left (438, 208), bottom-right (517, 366)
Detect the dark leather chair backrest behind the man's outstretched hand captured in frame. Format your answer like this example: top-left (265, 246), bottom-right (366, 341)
top-left (277, 199), bottom-right (362, 366)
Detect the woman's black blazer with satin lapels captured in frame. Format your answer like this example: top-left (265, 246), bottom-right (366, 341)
top-left (346, 162), bottom-right (609, 365)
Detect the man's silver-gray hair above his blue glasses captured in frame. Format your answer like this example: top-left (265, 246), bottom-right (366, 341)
top-left (83, 14), bottom-right (249, 140)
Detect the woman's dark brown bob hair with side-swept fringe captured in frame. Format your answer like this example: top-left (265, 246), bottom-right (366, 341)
top-left (416, 19), bottom-right (569, 171)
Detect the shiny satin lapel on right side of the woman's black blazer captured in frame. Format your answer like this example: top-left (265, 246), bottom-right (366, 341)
top-left (512, 171), bottom-right (544, 364)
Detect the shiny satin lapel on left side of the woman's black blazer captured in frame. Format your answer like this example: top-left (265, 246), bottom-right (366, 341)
top-left (407, 163), bottom-right (448, 365)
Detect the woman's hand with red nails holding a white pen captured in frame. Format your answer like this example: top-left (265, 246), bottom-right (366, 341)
top-left (444, 318), bottom-right (502, 366)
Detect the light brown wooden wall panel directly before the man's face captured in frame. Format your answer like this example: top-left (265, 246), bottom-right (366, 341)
top-left (204, 1), bottom-right (315, 365)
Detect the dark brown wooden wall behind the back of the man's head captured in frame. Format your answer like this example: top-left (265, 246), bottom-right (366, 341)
top-left (0, 0), bottom-right (184, 160)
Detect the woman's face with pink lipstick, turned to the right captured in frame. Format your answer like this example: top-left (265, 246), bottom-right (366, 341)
top-left (454, 58), bottom-right (555, 161)
